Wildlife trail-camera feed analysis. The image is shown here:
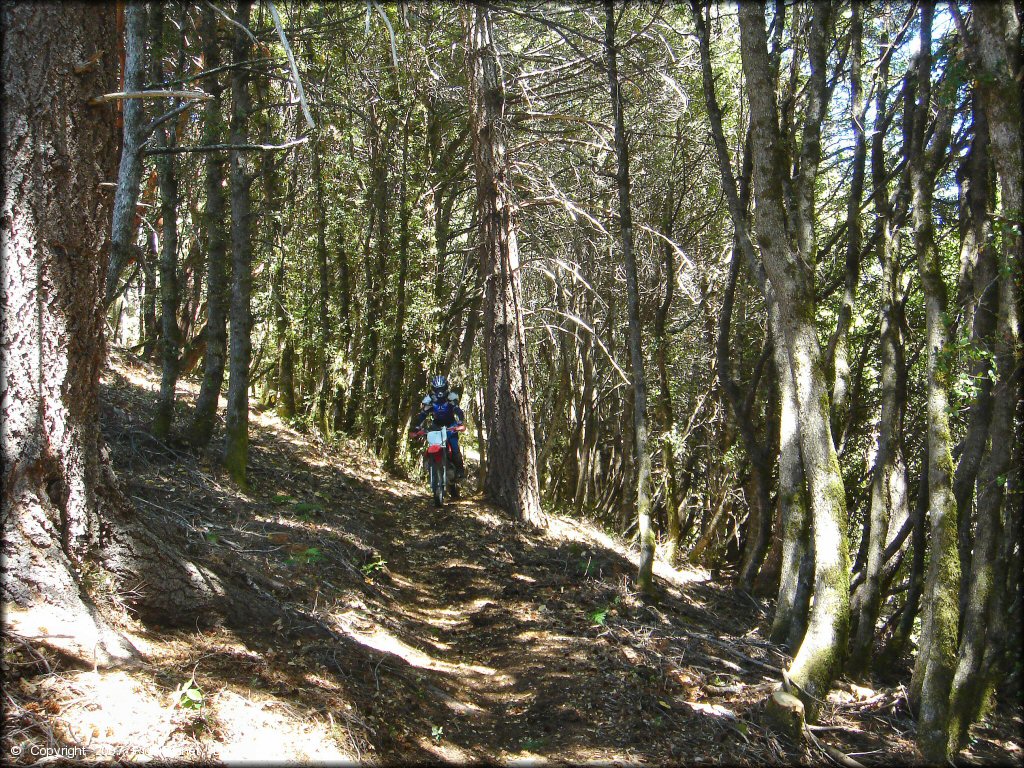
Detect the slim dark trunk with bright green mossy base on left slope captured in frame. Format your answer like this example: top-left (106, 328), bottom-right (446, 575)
top-left (223, 0), bottom-right (252, 487)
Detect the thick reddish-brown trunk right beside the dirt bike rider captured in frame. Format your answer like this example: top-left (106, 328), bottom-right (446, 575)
top-left (468, 5), bottom-right (544, 524)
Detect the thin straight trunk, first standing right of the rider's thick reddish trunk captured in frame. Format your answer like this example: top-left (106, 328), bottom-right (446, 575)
top-left (604, 0), bottom-right (654, 595)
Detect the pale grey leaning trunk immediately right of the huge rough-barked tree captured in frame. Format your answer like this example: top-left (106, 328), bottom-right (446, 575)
top-left (103, 2), bottom-right (145, 305)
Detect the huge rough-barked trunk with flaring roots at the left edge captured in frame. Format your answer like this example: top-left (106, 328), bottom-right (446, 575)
top-left (0, 3), bottom-right (280, 665)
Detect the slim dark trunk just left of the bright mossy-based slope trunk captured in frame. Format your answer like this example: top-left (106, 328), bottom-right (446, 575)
top-left (189, 7), bottom-right (227, 446)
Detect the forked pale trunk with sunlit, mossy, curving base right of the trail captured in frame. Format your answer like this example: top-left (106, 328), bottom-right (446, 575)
top-left (739, 3), bottom-right (850, 718)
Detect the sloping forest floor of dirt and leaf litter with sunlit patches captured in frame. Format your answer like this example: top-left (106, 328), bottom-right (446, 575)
top-left (3, 352), bottom-right (1024, 765)
